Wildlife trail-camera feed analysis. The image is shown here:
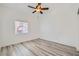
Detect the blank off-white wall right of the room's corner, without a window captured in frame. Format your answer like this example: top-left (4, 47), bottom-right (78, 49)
top-left (40, 4), bottom-right (79, 49)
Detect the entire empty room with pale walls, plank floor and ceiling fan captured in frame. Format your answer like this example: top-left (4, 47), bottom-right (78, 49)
top-left (0, 3), bottom-right (79, 56)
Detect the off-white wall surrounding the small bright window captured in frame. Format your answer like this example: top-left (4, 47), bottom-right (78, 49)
top-left (0, 4), bottom-right (39, 47)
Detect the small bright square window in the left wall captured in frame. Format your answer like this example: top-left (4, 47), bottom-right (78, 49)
top-left (15, 21), bottom-right (28, 34)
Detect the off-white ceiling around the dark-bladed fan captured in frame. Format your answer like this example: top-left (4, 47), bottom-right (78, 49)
top-left (0, 3), bottom-right (79, 18)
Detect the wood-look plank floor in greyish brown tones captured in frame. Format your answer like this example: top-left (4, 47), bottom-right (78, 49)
top-left (0, 39), bottom-right (77, 56)
